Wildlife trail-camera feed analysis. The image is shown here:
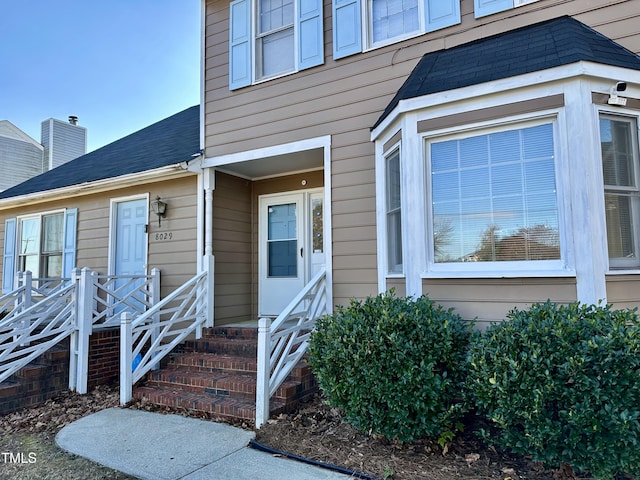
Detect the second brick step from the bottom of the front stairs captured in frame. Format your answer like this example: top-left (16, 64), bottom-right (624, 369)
top-left (145, 369), bottom-right (302, 403)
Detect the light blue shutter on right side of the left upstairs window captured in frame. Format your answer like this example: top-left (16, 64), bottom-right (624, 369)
top-left (297, 0), bottom-right (324, 70)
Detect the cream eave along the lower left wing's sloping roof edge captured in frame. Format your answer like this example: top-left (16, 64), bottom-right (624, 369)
top-left (0, 162), bottom-right (194, 210)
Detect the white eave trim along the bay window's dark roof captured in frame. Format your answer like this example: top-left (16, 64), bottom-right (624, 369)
top-left (371, 60), bottom-right (640, 141)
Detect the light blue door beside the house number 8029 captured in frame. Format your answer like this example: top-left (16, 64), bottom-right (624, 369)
top-left (112, 198), bottom-right (148, 313)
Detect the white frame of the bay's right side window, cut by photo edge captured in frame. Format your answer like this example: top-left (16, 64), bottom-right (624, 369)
top-left (595, 108), bottom-right (640, 273)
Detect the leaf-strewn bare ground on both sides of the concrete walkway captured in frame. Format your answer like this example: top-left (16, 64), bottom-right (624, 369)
top-left (0, 387), bottom-right (596, 480)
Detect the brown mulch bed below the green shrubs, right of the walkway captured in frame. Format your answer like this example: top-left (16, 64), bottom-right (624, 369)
top-left (256, 399), bottom-right (580, 480)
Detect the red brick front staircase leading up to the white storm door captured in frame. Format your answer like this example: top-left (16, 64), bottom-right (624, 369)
top-left (133, 327), bottom-right (317, 421)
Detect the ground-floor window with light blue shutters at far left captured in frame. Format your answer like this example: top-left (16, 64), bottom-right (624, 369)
top-left (2, 208), bottom-right (78, 292)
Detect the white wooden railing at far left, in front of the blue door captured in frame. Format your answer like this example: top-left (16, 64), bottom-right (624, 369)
top-left (0, 268), bottom-right (160, 393)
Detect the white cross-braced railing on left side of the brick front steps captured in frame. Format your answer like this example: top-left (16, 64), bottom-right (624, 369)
top-left (120, 271), bottom-right (207, 404)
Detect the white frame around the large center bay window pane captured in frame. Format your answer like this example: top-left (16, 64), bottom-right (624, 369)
top-left (421, 115), bottom-right (575, 278)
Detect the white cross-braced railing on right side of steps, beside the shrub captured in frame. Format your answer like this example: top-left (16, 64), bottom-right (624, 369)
top-left (256, 269), bottom-right (328, 428)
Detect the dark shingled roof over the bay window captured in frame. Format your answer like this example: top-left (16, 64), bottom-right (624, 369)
top-left (372, 16), bottom-right (640, 129)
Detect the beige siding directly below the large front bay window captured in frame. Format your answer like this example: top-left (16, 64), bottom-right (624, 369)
top-left (422, 278), bottom-right (577, 328)
